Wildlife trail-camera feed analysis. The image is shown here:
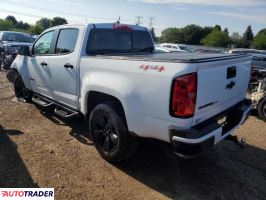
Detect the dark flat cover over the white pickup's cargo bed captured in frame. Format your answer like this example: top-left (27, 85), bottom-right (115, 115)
top-left (90, 52), bottom-right (249, 63)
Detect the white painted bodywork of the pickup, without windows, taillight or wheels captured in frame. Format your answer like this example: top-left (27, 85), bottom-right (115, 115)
top-left (12, 24), bottom-right (251, 145)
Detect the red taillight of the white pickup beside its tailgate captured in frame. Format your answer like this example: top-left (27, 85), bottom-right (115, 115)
top-left (170, 73), bottom-right (197, 118)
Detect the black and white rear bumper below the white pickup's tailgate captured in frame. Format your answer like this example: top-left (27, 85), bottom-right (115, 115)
top-left (170, 100), bottom-right (252, 158)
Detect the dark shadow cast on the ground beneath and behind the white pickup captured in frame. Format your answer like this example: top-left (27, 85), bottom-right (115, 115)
top-left (38, 112), bottom-right (266, 200)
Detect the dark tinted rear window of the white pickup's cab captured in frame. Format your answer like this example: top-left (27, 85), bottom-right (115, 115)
top-left (87, 29), bottom-right (154, 54)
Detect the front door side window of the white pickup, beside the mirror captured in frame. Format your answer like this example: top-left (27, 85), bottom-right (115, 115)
top-left (33, 31), bottom-right (54, 55)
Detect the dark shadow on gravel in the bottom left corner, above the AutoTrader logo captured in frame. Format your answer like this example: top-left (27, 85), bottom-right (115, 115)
top-left (0, 125), bottom-right (38, 188)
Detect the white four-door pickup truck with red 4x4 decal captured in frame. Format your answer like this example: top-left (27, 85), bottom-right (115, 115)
top-left (11, 23), bottom-right (251, 162)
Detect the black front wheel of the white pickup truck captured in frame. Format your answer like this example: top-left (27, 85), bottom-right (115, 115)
top-left (14, 74), bottom-right (32, 102)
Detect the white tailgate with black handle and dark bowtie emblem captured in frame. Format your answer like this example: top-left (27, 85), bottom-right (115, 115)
top-left (193, 56), bottom-right (251, 125)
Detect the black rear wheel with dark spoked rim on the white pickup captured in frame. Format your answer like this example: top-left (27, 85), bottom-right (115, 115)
top-left (89, 102), bottom-right (137, 162)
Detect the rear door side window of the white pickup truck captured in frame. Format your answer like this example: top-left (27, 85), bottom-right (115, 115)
top-left (55, 29), bottom-right (79, 54)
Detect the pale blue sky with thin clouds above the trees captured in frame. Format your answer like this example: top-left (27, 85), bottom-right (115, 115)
top-left (0, 0), bottom-right (266, 36)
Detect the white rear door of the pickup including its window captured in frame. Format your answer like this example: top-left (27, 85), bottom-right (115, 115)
top-left (46, 28), bottom-right (82, 108)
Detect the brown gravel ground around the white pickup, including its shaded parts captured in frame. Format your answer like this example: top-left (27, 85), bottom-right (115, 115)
top-left (0, 74), bottom-right (266, 200)
